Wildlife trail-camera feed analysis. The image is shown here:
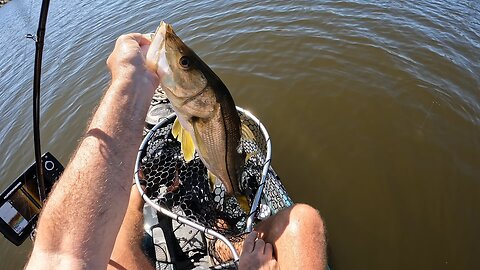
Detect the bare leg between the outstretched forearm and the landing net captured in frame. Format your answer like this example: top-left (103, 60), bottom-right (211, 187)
top-left (107, 186), bottom-right (154, 270)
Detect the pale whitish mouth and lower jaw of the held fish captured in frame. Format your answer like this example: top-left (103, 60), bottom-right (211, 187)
top-left (146, 21), bottom-right (173, 87)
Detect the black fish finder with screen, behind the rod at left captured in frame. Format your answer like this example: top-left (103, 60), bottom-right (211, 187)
top-left (0, 152), bottom-right (64, 246)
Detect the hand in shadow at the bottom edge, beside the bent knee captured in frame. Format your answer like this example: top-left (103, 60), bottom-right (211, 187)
top-left (238, 231), bottom-right (278, 270)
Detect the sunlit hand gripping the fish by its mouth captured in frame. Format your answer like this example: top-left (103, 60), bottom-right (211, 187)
top-left (107, 33), bottom-right (159, 95)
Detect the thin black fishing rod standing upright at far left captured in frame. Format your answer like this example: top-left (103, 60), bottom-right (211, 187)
top-left (26, 0), bottom-right (50, 204)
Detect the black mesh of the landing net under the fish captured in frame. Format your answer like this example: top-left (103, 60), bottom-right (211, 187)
top-left (140, 110), bottom-right (292, 262)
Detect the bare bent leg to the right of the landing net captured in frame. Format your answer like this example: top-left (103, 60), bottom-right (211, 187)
top-left (215, 204), bottom-right (327, 270)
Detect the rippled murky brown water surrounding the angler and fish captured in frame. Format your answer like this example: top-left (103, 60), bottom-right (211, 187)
top-left (0, 0), bottom-right (480, 269)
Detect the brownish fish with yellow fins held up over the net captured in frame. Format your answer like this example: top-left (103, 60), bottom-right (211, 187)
top-left (146, 21), bottom-right (251, 210)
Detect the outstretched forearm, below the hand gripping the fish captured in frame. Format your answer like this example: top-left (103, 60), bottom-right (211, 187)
top-left (29, 78), bottom-right (153, 268)
